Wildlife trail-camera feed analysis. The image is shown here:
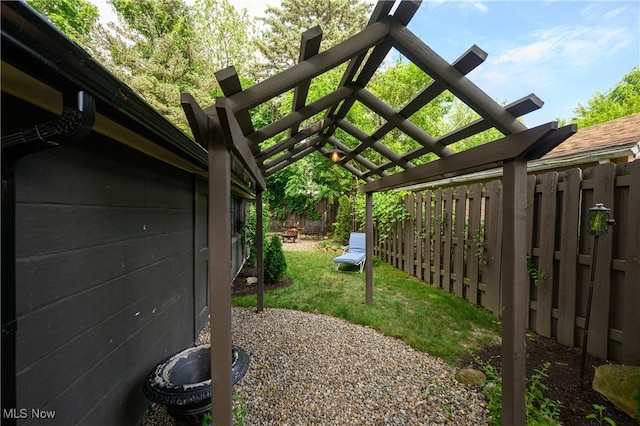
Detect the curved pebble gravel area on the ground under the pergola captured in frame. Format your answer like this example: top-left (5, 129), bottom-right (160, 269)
top-left (192, 308), bottom-right (487, 426)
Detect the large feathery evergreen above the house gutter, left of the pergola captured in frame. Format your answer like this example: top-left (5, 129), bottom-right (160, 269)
top-left (96, 0), bottom-right (206, 131)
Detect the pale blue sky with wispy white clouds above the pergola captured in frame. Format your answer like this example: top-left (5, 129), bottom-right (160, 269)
top-left (92, 0), bottom-right (640, 127)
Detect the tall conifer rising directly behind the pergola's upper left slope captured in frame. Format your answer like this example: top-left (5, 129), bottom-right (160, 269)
top-left (257, 0), bottom-right (372, 75)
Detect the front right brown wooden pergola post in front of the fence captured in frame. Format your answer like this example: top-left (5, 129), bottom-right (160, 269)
top-left (501, 157), bottom-right (528, 425)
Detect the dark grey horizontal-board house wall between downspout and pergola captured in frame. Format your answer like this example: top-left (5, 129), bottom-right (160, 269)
top-left (16, 134), bottom-right (195, 425)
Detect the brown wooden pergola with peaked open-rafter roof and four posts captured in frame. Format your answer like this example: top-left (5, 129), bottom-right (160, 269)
top-left (182, 0), bottom-right (576, 425)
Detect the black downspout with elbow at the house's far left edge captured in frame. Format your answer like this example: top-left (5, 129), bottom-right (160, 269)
top-left (1, 91), bottom-right (95, 425)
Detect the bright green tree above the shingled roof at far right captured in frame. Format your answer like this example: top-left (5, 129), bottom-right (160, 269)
top-left (572, 66), bottom-right (640, 127)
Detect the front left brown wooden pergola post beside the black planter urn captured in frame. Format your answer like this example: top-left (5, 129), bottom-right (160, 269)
top-left (209, 134), bottom-right (233, 426)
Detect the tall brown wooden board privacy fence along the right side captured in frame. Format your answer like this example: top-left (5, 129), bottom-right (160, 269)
top-left (374, 160), bottom-right (640, 365)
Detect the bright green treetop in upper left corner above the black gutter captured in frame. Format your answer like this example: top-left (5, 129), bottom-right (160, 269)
top-left (28, 0), bottom-right (100, 43)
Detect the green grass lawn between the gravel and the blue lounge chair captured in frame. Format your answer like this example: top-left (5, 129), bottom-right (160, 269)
top-left (233, 251), bottom-right (500, 365)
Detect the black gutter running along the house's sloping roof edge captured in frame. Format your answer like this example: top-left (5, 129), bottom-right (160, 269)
top-left (0, 1), bottom-right (208, 170)
